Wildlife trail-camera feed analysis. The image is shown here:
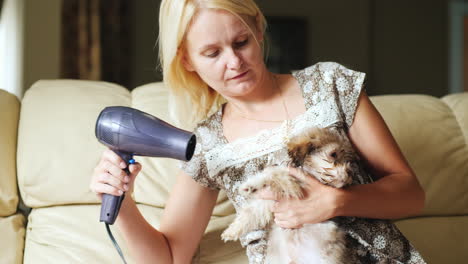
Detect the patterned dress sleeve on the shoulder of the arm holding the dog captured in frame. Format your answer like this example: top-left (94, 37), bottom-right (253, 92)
top-left (334, 64), bottom-right (366, 128)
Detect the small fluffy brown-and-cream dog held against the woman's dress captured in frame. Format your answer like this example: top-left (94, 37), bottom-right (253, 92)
top-left (221, 128), bottom-right (358, 264)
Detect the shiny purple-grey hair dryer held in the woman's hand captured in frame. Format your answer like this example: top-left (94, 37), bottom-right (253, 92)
top-left (95, 106), bottom-right (196, 225)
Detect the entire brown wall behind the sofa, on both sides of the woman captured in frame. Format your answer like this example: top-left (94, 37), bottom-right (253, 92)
top-left (20, 0), bottom-right (448, 96)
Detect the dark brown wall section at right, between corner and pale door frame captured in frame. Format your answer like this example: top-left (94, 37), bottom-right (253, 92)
top-left (370, 0), bottom-right (449, 96)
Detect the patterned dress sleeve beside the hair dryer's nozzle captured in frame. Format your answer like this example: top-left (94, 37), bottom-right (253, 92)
top-left (179, 127), bottom-right (220, 190)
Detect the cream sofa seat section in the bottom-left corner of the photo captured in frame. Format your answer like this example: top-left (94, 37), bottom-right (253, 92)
top-left (0, 214), bottom-right (25, 264)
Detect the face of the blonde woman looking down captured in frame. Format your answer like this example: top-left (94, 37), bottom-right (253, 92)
top-left (183, 9), bottom-right (266, 97)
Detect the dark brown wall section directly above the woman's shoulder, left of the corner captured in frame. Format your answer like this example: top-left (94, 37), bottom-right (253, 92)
top-left (257, 0), bottom-right (370, 76)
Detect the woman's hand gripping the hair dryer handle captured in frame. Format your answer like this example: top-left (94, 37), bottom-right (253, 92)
top-left (89, 149), bottom-right (141, 199)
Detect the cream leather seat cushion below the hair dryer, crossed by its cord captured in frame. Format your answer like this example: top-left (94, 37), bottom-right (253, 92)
top-left (24, 205), bottom-right (133, 264)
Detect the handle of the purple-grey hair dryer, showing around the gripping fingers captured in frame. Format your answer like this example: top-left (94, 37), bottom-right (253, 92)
top-left (99, 151), bottom-right (135, 225)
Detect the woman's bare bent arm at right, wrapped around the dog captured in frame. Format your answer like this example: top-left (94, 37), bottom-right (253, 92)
top-left (335, 92), bottom-right (425, 219)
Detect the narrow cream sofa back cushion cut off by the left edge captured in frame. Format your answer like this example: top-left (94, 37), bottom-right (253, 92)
top-left (0, 90), bottom-right (20, 216)
